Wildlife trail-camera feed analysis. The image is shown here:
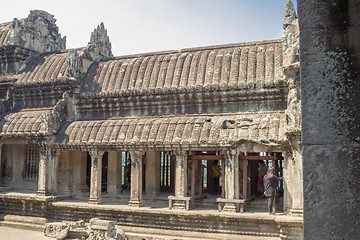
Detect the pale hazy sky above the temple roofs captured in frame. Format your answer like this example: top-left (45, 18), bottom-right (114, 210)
top-left (0, 0), bottom-right (296, 56)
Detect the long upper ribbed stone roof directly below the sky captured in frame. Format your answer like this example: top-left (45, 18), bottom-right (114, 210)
top-left (82, 41), bottom-right (283, 94)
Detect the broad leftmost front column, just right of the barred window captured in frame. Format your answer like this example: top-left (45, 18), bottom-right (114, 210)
top-left (37, 144), bottom-right (60, 196)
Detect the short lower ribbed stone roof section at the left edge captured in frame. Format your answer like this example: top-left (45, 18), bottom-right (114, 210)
top-left (0, 109), bottom-right (45, 137)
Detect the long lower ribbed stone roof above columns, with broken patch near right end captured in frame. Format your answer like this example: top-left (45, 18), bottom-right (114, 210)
top-left (54, 112), bottom-right (285, 147)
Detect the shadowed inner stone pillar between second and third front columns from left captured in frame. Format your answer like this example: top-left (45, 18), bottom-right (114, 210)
top-left (107, 151), bottom-right (122, 198)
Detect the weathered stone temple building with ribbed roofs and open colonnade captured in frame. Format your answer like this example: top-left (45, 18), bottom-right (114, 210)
top-left (0, 1), bottom-right (303, 239)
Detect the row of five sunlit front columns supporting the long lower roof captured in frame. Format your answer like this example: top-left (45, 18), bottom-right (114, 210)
top-left (37, 146), bottom-right (239, 207)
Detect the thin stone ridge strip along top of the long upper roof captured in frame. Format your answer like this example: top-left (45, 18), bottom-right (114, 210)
top-left (106, 39), bottom-right (281, 61)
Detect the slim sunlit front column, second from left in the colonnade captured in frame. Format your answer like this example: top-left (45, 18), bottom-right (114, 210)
top-left (89, 150), bottom-right (104, 204)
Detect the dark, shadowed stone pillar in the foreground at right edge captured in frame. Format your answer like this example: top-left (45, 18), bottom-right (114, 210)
top-left (298, 0), bottom-right (360, 239)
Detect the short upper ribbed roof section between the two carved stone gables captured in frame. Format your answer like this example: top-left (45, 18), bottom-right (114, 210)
top-left (16, 52), bottom-right (69, 85)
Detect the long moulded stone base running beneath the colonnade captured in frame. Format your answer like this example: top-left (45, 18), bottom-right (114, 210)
top-left (0, 195), bottom-right (302, 239)
